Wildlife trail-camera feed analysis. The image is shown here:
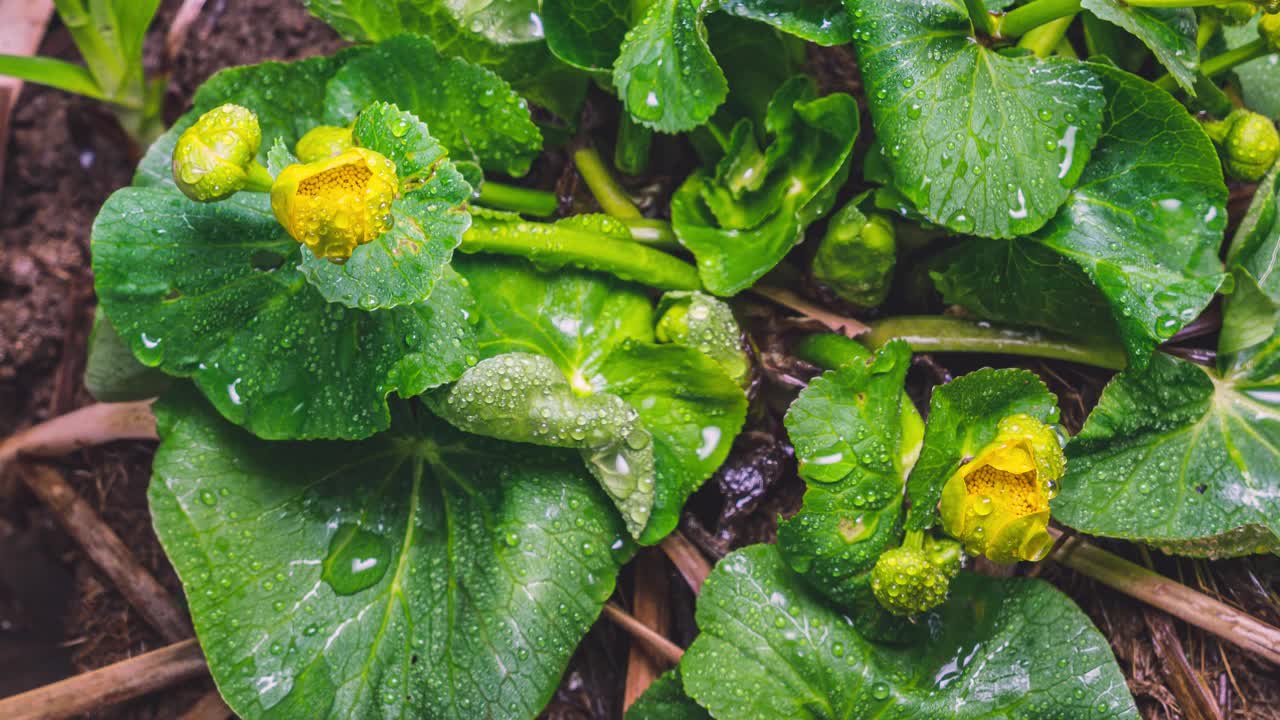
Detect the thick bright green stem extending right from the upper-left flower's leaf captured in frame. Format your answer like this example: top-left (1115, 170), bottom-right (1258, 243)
top-left (460, 217), bottom-right (703, 290)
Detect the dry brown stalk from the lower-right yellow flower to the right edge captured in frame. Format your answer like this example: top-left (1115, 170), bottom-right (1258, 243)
top-left (1050, 528), bottom-right (1280, 665)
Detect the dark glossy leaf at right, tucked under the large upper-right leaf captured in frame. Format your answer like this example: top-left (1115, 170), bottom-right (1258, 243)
top-left (1036, 64), bottom-right (1226, 368)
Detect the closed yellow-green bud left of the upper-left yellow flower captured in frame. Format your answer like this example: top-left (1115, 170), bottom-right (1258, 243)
top-left (173, 104), bottom-right (271, 202)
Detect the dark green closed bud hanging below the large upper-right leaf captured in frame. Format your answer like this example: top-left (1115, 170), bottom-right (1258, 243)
top-left (813, 196), bottom-right (897, 307)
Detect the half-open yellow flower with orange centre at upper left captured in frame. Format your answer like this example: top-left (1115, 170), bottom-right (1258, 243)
top-left (271, 147), bottom-right (399, 263)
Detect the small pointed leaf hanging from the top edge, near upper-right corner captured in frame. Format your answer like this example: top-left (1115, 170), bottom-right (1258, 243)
top-left (1080, 0), bottom-right (1199, 97)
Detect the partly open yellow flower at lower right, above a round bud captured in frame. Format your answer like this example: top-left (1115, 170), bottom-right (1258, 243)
top-left (940, 415), bottom-right (1066, 564)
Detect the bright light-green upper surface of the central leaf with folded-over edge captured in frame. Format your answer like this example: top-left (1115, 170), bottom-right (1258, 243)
top-left (454, 258), bottom-right (746, 544)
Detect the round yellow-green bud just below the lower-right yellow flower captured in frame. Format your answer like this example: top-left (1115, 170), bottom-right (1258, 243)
top-left (872, 532), bottom-right (964, 616)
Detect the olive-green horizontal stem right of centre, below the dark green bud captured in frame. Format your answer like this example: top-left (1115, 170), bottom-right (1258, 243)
top-left (863, 315), bottom-right (1126, 370)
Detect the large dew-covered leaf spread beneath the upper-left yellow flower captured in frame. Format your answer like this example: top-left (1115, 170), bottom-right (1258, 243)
top-left (92, 186), bottom-right (475, 439)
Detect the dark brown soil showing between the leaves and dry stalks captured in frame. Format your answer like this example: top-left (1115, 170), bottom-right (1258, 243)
top-left (0, 0), bottom-right (1280, 720)
